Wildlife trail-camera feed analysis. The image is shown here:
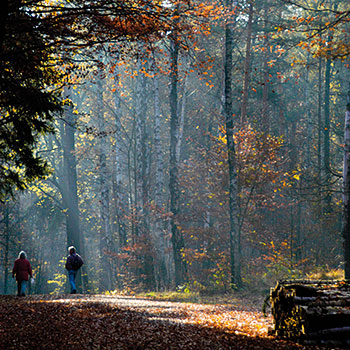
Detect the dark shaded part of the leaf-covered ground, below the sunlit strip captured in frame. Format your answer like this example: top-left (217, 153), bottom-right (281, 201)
top-left (0, 296), bottom-right (326, 350)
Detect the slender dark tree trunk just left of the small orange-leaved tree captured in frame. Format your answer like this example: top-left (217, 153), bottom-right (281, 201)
top-left (224, 1), bottom-right (242, 288)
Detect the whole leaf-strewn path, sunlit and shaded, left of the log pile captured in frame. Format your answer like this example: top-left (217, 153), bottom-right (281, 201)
top-left (0, 294), bottom-right (334, 350)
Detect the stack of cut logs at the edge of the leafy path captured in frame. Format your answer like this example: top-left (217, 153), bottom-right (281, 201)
top-left (271, 281), bottom-right (350, 349)
